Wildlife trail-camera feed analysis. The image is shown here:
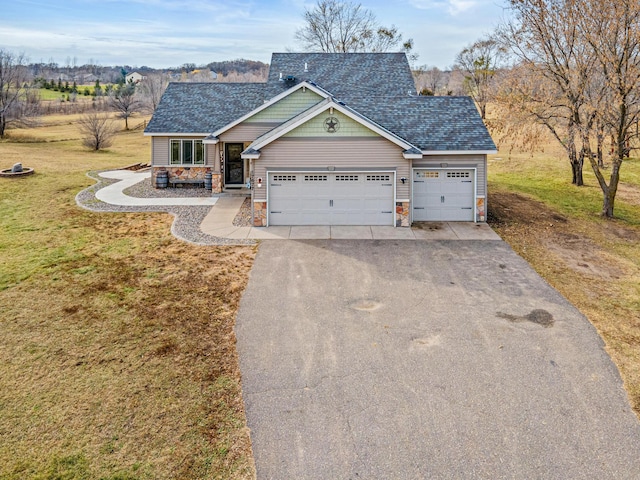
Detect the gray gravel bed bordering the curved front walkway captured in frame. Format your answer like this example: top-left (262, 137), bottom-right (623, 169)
top-left (76, 170), bottom-right (257, 246)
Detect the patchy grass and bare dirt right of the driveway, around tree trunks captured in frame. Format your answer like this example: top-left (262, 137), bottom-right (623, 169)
top-left (488, 143), bottom-right (640, 414)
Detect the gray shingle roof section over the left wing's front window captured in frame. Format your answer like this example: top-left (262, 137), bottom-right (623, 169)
top-left (145, 83), bottom-right (265, 134)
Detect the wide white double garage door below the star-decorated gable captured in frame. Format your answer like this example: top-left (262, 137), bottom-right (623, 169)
top-left (268, 172), bottom-right (394, 225)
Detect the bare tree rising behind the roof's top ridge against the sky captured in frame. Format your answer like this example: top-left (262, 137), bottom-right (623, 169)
top-left (295, 0), bottom-right (415, 60)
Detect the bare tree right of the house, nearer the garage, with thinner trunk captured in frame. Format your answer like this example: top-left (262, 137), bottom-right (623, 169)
top-left (501, 0), bottom-right (595, 186)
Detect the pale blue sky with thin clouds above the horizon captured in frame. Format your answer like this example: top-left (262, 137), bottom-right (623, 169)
top-left (0, 0), bottom-right (503, 68)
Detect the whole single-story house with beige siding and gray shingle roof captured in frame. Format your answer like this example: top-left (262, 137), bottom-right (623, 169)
top-left (145, 53), bottom-right (496, 227)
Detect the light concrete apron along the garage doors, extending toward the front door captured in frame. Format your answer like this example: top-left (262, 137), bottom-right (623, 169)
top-left (200, 197), bottom-right (500, 240)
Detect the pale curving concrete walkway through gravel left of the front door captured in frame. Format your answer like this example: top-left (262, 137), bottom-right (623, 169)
top-left (96, 170), bottom-right (218, 207)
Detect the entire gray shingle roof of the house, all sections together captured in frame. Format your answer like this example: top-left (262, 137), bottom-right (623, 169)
top-left (145, 53), bottom-right (496, 151)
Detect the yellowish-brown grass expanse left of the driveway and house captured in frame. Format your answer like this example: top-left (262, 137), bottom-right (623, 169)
top-left (0, 116), bottom-right (255, 480)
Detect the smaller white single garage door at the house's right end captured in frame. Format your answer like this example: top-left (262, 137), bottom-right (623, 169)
top-left (413, 169), bottom-right (474, 222)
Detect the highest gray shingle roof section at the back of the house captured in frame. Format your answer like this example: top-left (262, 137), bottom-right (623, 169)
top-left (266, 53), bottom-right (416, 102)
